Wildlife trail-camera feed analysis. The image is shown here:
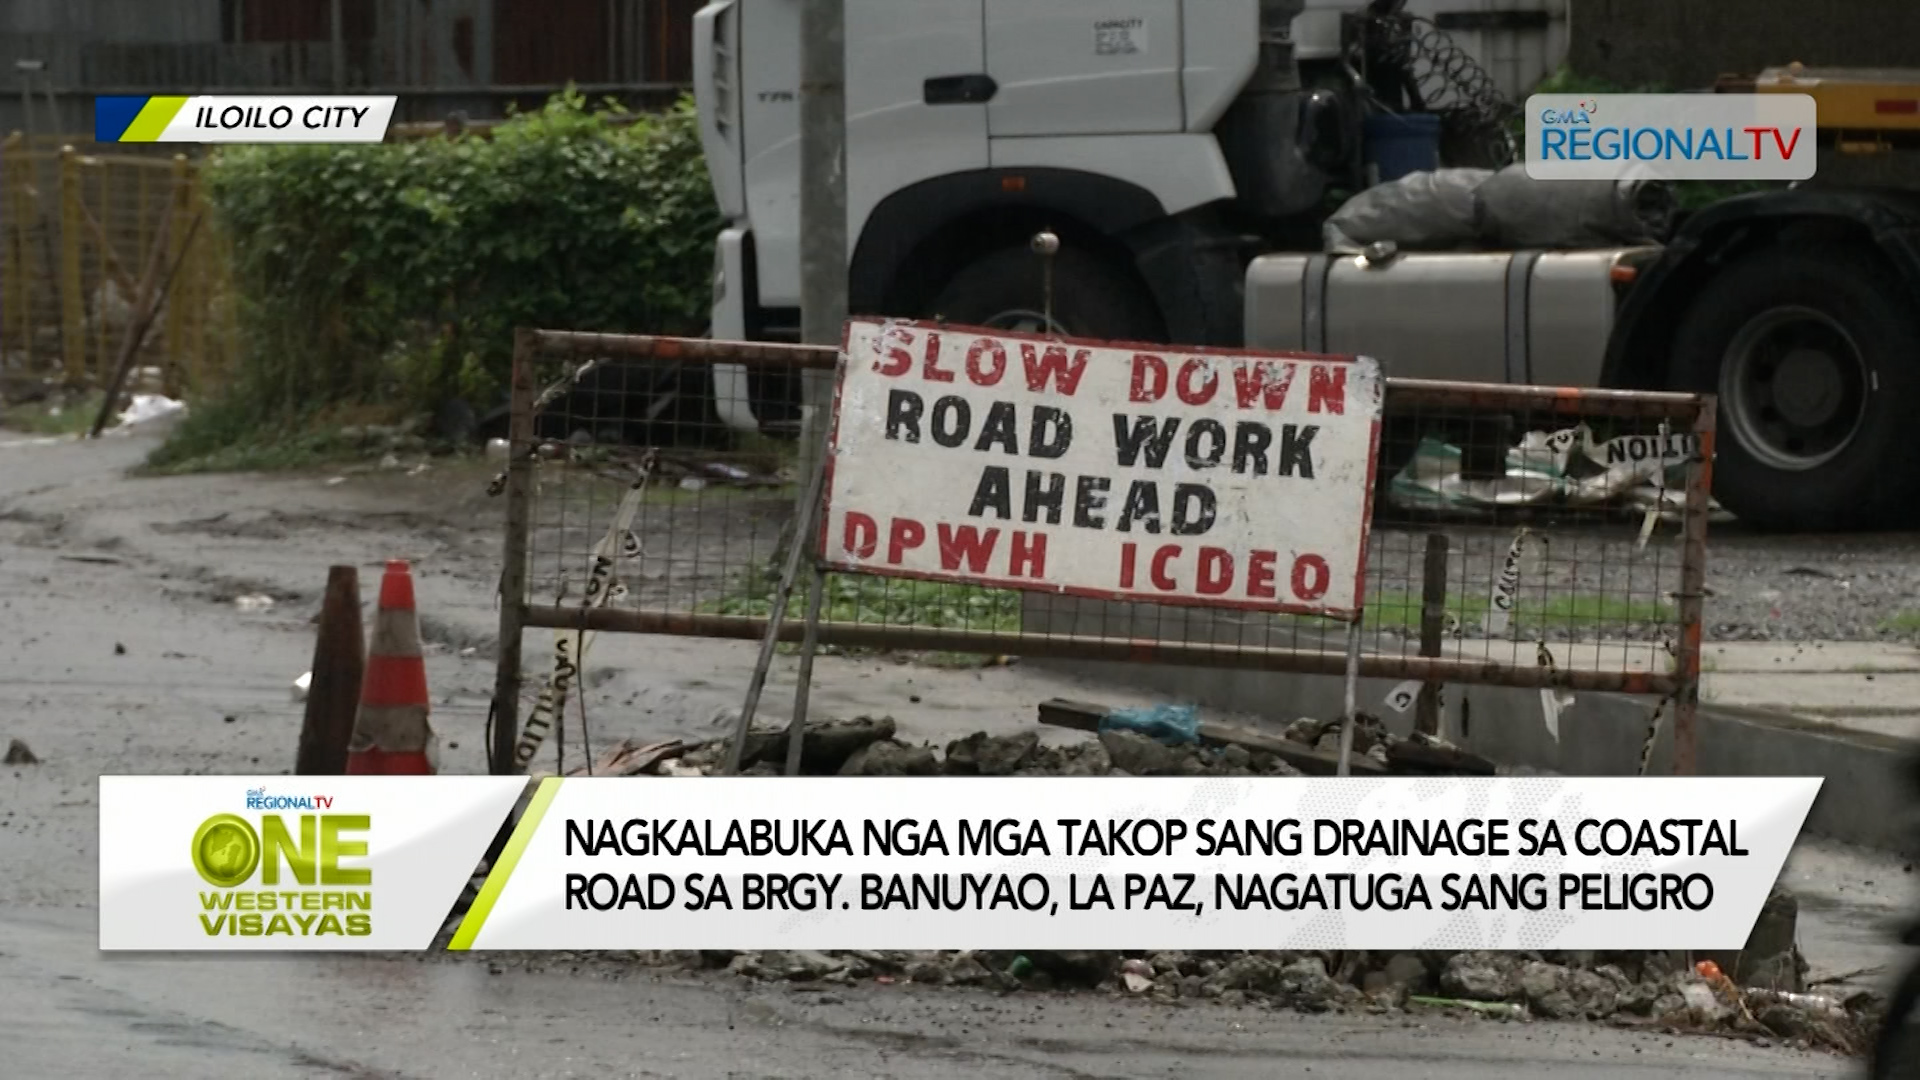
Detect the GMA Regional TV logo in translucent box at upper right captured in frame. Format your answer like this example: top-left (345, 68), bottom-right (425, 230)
top-left (1526, 94), bottom-right (1818, 181)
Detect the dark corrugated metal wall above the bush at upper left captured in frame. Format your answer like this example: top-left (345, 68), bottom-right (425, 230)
top-left (0, 0), bottom-right (701, 135)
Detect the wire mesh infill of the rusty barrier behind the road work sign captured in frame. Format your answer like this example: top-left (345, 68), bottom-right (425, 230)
top-left (501, 332), bottom-right (1713, 711)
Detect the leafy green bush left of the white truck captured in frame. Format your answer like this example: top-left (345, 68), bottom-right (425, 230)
top-left (163, 92), bottom-right (720, 457)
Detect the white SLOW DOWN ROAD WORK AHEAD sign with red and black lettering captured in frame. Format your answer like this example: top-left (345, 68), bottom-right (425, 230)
top-left (820, 319), bottom-right (1384, 617)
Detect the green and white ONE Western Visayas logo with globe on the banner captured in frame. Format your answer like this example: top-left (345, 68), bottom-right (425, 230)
top-left (194, 788), bottom-right (372, 938)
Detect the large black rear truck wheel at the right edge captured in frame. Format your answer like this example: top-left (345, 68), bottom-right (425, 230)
top-left (1672, 250), bottom-right (1920, 530)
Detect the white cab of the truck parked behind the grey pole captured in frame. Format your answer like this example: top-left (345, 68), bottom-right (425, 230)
top-left (695, 0), bottom-right (1567, 427)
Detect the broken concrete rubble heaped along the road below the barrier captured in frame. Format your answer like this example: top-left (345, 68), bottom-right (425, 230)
top-left (533, 717), bottom-right (1882, 1053)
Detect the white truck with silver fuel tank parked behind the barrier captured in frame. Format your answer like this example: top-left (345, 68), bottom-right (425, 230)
top-left (695, 0), bottom-right (1920, 528)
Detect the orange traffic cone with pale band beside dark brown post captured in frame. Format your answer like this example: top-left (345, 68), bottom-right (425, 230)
top-left (348, 559), bottom-right (436, 776)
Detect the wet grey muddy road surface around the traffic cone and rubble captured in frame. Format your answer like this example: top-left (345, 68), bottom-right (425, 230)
top-left (0, 424), bottom-right (1907, 1080)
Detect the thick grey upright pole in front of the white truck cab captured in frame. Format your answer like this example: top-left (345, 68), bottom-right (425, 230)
top-left (795, 0), bottom-right (847, 522)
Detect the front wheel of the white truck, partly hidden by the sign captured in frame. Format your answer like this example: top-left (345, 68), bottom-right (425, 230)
top-left (931, 246), bottom-right (1167, 342)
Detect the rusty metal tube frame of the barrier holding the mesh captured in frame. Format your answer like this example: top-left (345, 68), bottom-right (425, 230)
top-left (492, 331), bottom-right (1715, 774)
